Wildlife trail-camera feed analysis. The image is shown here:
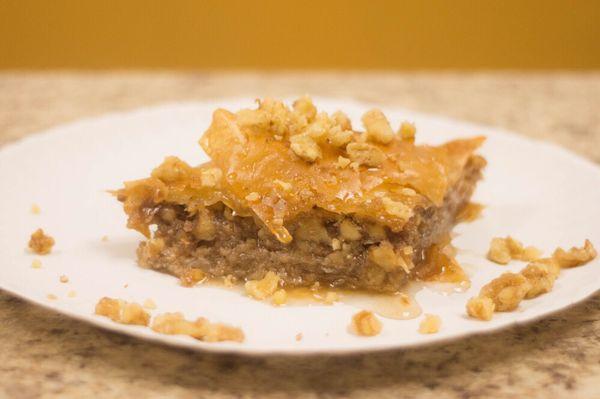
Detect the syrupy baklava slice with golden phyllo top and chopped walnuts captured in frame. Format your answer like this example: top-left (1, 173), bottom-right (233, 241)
top-left (116, 97), bottom-right (485, 292)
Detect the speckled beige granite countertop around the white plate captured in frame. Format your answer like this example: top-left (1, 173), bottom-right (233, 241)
top-left (0, 72), bottom-right (600, 398)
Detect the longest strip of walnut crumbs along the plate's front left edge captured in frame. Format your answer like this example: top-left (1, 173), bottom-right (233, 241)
top-left (151, 313), bottom-right (244, 342)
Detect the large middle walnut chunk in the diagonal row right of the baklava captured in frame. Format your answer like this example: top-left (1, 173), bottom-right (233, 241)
top-left (479, 273), bottom-right (531, 312)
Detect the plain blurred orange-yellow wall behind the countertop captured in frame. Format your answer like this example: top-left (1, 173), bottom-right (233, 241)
top-left (0, 0), bottom-right (600, 69)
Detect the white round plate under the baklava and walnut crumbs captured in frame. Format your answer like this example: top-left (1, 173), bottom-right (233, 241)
top-left (0, 99), bottom-right (600, 354)
